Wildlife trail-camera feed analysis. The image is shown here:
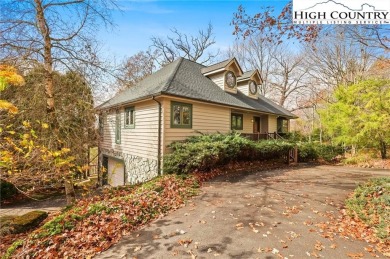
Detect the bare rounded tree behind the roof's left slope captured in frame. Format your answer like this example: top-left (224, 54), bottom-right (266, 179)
top-left (118, 51), bottom-right (157, 90)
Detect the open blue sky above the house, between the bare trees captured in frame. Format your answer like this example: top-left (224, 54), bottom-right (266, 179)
top-left (99, 0), bottom-right (288, 60)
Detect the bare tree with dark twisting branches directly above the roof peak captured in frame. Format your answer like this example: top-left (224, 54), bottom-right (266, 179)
top-left (151, 24), bottom-right (219, 66)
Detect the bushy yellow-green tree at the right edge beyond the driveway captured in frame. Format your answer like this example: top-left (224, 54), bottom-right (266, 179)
top-left (321, 79), bottom-right (390, 159)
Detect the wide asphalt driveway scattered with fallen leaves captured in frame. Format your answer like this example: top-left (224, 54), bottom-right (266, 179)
top-left (97, 166), bottom-right (390, 258)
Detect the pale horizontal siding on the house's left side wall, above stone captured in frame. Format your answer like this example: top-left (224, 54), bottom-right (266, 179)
top-left (101, 101), bottom-right (158, 159)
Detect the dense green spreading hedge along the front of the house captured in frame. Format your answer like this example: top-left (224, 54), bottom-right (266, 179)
top-left (164, 133), bottom-right (293, 174)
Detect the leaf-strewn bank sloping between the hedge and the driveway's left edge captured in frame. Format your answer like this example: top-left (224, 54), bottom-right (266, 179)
top-left (0, 162), bottom-right (281, 258)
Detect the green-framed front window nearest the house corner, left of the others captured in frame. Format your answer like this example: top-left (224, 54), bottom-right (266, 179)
top-left (171, 102), bottom-right (192, 129)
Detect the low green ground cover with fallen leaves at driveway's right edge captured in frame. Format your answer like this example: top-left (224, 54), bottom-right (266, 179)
top-left (346, 177), bottom-right (390, 242)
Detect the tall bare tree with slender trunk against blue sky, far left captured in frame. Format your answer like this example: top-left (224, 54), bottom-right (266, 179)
top-left (0, 0), bottom-right (113, 131)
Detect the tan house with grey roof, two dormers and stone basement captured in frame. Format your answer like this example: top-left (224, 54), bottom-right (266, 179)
top-left (97, 58), bottom-right (296, 186)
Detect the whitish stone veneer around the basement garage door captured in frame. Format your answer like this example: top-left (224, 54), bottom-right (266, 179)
top-left (100, 148), bottom-right (158, 184)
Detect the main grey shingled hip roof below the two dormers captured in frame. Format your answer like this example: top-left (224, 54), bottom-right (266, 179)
top-left (97, 58), bottom-right (296, 117)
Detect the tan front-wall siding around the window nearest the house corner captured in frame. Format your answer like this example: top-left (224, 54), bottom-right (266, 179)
top-left (162, 98), bottom-right (230, 154)
